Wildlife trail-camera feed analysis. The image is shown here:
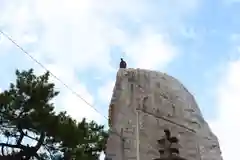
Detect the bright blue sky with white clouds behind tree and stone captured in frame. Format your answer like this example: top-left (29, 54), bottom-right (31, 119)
top-left (0, 0), bottom-right (240, 160)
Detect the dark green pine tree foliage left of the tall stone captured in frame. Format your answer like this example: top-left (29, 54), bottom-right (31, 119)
top-left (0, 69), bottom-right (108, 160)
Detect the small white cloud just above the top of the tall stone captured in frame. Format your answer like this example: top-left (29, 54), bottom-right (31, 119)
top-left (126, 29), bottom-right (176, 69)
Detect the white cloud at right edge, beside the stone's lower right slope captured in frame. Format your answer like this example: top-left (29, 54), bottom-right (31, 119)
top-left (210, 60), bottom-right (240, 160)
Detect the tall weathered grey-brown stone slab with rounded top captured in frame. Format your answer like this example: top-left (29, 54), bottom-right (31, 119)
top-left (106, 69), bottom-right (222, 160)
